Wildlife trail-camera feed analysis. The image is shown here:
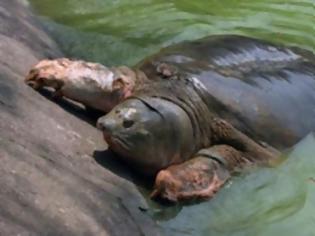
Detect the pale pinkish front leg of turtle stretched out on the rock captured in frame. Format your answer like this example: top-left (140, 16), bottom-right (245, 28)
top-left (25, 58), bottom-right (146, 113)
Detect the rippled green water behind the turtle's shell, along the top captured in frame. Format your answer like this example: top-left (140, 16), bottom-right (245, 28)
top-left (31, 0), bottom-right (315, 65)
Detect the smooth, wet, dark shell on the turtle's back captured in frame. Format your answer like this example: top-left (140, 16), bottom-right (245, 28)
top-left (138, 36), bottom-right (315, 147)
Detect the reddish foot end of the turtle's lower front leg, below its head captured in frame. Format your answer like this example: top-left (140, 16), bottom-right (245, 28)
top-left (151, 157), bottom-right (230, 202)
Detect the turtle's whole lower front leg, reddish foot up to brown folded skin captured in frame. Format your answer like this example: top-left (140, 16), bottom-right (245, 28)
top-left (151, 145), bottom-right (251, 202)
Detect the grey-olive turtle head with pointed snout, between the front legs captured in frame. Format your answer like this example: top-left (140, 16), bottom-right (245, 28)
top-left (97, 97), bottom-right (193, 175)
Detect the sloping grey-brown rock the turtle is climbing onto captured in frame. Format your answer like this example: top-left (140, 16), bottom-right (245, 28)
top-left (0, 0), bottom-right (160, 236)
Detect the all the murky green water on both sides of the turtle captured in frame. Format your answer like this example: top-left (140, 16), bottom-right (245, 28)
top-left (31, 0), bottom-right (315, 236)
